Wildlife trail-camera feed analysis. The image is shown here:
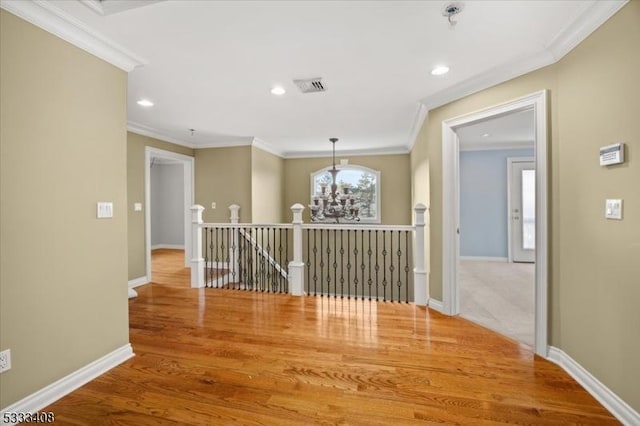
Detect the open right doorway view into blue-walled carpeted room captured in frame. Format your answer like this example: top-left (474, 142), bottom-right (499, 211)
top-left (456, 109), bottom-right (535, 347)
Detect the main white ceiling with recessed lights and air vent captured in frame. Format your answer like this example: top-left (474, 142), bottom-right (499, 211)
top-left (13, 0), bottom-right (624, 156)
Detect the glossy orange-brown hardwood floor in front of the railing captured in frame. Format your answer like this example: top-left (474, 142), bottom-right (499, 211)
top-left (46, 251), bottom-right (618, 425)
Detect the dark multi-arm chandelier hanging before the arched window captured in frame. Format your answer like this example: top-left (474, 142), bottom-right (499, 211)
top-left (309, 138), bottom-right (360, 223)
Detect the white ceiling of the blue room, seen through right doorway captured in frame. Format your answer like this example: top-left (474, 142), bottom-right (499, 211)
top-left (456, 109), bottom-right (535, 151)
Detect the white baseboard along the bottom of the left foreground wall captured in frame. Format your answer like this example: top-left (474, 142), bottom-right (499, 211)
top-left (0, 343), bottom-right (134, 425)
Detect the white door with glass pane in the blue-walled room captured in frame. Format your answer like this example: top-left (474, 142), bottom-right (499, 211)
top-left (507, 158), bottom-right (536, 263)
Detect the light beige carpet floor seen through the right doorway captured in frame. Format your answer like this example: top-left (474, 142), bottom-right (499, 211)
top-left (459, 260), bottom-right (535, 347)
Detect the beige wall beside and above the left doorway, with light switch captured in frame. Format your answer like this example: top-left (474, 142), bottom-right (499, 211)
top-left (127, 132), bottom-right (194, 280)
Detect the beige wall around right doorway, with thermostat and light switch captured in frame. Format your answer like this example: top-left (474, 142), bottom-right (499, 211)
top-left (411, 1), bottom-right (640, 410)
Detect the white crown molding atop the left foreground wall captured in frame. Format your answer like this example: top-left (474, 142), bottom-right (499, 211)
top-left (0, 0), bottom-right (147, 72)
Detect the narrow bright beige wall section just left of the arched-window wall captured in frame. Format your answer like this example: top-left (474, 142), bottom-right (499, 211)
top-left (251, 147), bottom-right (284, 223)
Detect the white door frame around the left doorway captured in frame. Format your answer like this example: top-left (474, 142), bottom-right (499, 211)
top-left (144, 146), bottom-right (195, 282)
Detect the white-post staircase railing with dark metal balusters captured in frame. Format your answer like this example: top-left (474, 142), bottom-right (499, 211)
top-left (191, 204), bottom-right (428, 306)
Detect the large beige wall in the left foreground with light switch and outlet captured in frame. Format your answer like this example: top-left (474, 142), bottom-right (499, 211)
top-left (0, 10), bottom-right (129, 408)
